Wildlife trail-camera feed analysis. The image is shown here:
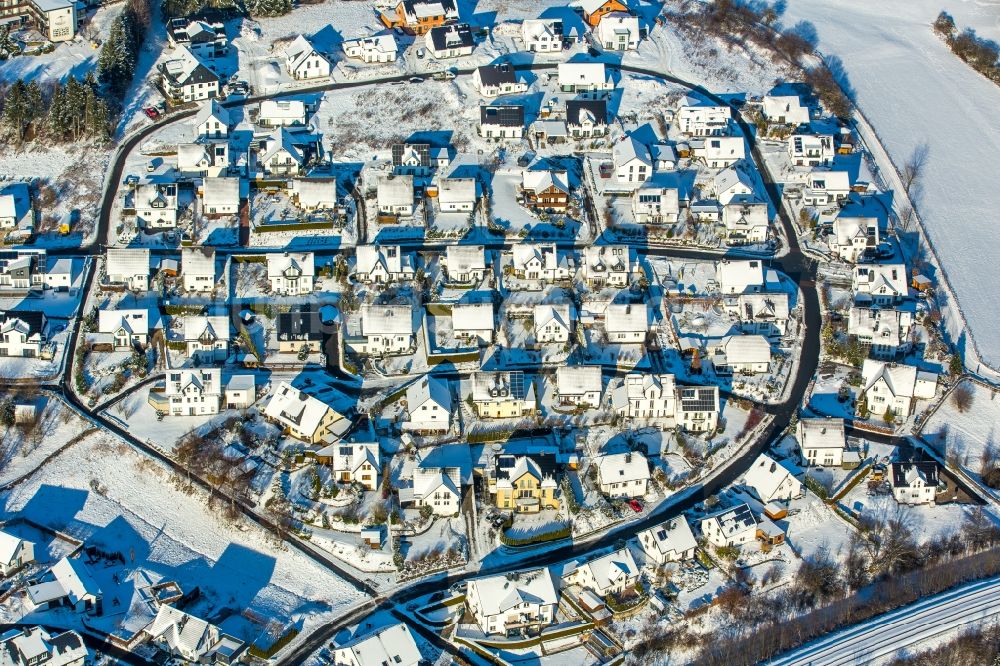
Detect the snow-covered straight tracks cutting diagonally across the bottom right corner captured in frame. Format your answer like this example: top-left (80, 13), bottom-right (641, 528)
top-left (768, 577), bottom-right (1000, 666)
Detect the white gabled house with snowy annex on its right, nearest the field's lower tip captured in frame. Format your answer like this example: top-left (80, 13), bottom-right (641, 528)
top-left (858, 359), bottom-right (937, 419)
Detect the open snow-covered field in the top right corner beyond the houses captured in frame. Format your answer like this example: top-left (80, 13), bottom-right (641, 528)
top-left (783, 0), bottom-right (1000, 370)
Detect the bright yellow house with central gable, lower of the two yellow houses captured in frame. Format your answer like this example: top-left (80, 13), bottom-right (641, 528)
top-left (491, 454), bottom-right (559, 513)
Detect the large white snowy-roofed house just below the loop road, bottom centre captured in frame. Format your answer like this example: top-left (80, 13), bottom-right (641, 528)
top-left (465, 568), bottom-right (559, 635)
